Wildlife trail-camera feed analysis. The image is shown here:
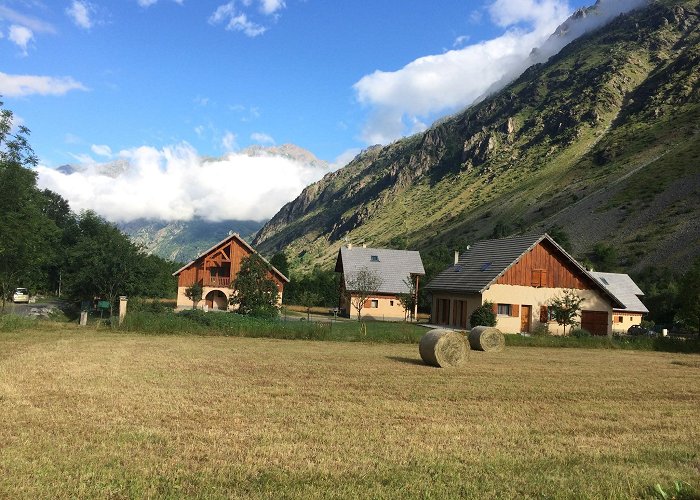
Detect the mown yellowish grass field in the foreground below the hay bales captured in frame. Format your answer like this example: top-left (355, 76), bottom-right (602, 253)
top-left (0, 325), bottom-right (700, 498)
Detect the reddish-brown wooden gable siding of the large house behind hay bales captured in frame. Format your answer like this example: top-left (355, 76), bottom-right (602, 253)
top-left (496, 241), bottom-right (594, 290)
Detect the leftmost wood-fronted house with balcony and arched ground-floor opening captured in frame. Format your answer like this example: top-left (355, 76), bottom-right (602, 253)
top-left (173, 233), bottom-right (289, 311)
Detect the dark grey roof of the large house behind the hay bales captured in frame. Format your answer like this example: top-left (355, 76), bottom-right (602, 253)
top-left (425, 233), bottom-right (622, 306)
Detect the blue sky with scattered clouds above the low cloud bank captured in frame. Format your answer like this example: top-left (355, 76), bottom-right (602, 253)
top-left (0, 0), bottom-right (636, 220)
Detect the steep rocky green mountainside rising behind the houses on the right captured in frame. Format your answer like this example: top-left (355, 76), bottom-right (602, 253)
top-left (254, 0), bottom-right (700, 271)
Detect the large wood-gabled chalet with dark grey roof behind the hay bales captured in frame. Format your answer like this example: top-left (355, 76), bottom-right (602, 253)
top-left (426, 234), bottom-right (624, 335)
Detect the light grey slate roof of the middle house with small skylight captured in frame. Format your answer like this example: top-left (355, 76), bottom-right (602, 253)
top-left (335, 247), bottom-right (425, 294)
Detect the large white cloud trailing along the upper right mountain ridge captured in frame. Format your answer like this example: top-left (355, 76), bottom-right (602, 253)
top-left (353, 0), bottom-right (645, 144)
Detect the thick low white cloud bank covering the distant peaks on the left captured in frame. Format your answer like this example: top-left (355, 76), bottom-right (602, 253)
top-left (37, 144), bottom-right (328, 222)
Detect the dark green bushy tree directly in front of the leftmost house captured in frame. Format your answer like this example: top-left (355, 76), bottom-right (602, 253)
top-left (230, 253), bottom-right (279, 317)
